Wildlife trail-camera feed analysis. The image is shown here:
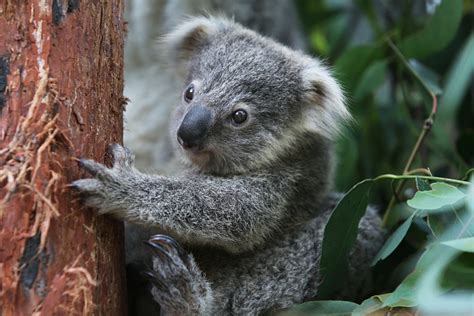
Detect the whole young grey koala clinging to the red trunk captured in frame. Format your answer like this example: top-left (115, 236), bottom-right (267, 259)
top-left (72, 17), bottom-right (383, 315)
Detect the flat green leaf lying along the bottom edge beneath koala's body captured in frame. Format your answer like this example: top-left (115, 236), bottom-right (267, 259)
top-left (277, 301), bottom-right (359, 316)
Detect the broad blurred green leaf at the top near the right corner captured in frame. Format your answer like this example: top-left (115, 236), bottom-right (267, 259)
top-left (399, 0), bottom-right (463, 58)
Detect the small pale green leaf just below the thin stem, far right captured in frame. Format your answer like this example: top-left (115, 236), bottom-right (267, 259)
top-left (407, 182), bottom-right (466, 210)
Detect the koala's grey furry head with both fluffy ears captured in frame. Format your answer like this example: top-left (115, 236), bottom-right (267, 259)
top-left (164, 18), bottom-right (349, 175)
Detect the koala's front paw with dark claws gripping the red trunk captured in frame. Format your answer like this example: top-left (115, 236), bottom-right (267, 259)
top-left (70, 144), bottom-right (134, 214)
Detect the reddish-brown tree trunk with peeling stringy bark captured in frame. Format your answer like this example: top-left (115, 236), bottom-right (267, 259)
top-left (0, 0), bottom-right (126, 316)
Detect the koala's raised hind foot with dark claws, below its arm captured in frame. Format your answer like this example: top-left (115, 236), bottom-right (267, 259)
top-left (146, 235), bottom-right (214, 315)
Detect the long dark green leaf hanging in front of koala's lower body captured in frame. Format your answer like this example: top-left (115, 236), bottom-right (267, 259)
top-left (319, 179), bottom-right (374, 297)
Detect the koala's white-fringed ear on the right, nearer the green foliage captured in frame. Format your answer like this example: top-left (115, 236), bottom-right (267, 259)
top-left (302, 60), bottom-right (351, 139)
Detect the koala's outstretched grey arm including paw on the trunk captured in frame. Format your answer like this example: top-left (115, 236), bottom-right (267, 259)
top-left (73, 145), bottom-right (292, 250)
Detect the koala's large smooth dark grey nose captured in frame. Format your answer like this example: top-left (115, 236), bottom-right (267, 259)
top-left (177, 106), bottom-right (212, 148)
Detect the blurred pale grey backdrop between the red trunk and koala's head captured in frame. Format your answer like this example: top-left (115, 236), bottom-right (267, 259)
top-left (124, 0), bottom-right (306, 173)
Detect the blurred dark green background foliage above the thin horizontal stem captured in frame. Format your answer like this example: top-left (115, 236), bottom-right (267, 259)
top-left (297, 0), bottom-right (474, 201)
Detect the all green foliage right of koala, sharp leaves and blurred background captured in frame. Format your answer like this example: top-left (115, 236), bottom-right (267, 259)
top-left (285, 0), bottom-right (474, 315)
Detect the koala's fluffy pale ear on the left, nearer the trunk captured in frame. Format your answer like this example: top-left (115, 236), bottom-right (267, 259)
top-left (159, 17), bottom-right (225, 71)
